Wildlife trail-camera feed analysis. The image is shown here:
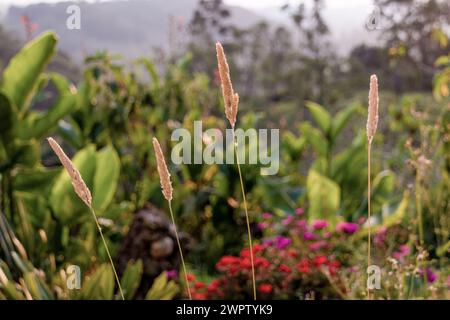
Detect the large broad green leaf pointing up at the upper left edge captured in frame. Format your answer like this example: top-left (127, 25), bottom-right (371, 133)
top-left (1, 32), bottom-right (57, 110)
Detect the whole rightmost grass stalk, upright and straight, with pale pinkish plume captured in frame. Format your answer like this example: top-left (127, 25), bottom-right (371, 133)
top-left (366, 75), bottom-right (378, 299)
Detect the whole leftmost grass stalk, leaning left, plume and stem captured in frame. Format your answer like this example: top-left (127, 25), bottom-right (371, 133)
top-left (47, 138), bottom-right (125, 300)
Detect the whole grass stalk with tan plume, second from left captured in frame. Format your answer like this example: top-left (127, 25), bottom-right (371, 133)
top-left (153, 138), bottom-right (192, 300)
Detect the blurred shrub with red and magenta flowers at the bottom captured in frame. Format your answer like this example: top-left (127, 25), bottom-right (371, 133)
top-left (187, 209), bottom-right (450, 299)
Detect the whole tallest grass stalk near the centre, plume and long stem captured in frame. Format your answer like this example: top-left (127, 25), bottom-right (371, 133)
top-left (216, 42), bottom-right (256, 300)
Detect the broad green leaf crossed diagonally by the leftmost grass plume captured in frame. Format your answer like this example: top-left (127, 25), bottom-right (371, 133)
top-left (50, 145), bottom-right (97, 223)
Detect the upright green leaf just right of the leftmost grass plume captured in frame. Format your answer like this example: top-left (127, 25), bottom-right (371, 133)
top-left (92, 146), bottom-right (120, 214)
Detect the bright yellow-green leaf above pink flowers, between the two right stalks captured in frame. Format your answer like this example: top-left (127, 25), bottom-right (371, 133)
top-left (306, 170), bottom-right (341, 221)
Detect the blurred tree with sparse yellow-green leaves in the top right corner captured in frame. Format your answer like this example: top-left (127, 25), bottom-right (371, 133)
top-left (374, 0), bottom-right (450, 91)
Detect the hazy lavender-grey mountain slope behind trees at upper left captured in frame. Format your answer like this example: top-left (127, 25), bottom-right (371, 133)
top-left (5, 0), bottom-right (262, 62)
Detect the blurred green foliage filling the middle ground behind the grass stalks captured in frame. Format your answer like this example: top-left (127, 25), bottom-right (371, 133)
top-left (0, 1), bottom-right (450, 299)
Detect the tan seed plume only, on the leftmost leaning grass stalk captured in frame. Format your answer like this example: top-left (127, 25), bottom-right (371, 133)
top-left (47, 138), bottom-right (92, 207)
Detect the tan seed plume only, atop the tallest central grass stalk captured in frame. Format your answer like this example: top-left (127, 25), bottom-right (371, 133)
top-left (216, 42), bottom-right (239, 128)
